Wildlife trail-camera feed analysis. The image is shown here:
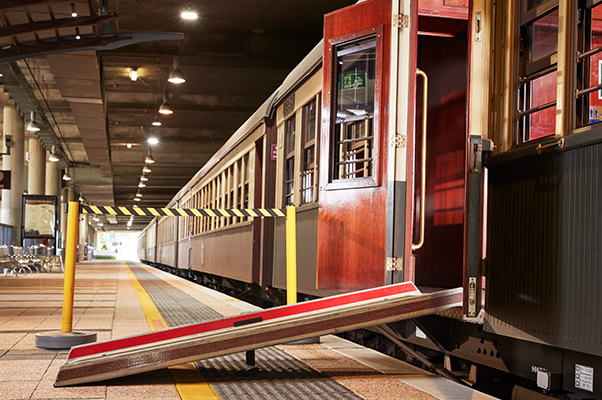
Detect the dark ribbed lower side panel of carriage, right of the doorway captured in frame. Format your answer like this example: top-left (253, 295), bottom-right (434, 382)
top-left (487, 144), bottom-right (602, 353)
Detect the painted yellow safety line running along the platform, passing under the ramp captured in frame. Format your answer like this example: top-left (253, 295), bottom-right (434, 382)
top-left (126, 265), bottom-right (219, 400)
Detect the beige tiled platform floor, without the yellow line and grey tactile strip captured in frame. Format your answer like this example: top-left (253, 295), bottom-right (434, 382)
top-left (0, 261), bottom-right (492, 400)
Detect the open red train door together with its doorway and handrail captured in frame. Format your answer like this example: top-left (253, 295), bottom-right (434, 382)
top-left (318, 0), bottom-right (480, 312)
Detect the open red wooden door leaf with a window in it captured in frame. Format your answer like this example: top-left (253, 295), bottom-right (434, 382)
top-left (317, 0), bottom-right (392, 290)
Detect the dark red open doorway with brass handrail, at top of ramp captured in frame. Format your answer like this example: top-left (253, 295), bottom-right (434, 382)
top-left (404, 5), bottom-right (468, 291)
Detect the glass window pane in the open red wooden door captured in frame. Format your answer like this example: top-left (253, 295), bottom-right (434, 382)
top-left (333, 37), bottom-right (376, 179)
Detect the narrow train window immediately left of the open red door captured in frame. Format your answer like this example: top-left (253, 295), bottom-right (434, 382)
top-left (301, 99), bottom-right (318, 203)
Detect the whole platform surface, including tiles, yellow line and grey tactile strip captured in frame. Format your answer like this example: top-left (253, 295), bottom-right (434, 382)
top-left (0, 260), bottom-right (493, 400)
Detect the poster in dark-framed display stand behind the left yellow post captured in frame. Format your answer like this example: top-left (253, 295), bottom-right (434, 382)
top-left (23, 195), bottom-right (57, 238)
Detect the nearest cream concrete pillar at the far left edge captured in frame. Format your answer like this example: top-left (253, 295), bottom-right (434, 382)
top-left (1, 105), bottom-right (25, 245)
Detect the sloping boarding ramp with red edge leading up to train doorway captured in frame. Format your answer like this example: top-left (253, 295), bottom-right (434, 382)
top-left (54, 282), bottom-right (462, 387)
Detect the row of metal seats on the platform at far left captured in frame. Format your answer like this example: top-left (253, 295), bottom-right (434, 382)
top-left (0, 244), bottom-right (64, 277)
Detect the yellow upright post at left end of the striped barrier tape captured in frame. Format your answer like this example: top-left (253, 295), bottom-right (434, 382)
top-left (61, 201), bottom-right (79, 332)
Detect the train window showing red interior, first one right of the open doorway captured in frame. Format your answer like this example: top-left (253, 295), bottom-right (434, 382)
top-left (516, 1), bottom-right (558, 144)
